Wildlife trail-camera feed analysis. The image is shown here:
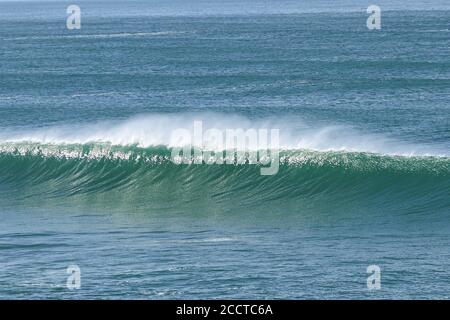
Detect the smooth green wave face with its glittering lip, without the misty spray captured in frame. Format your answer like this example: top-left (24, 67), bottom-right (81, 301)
top-left (0, 143), bottom-right (450, 213)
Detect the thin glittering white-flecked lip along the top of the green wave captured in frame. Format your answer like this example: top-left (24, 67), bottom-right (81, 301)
top-left (0, 143), bottom-right (450, 175)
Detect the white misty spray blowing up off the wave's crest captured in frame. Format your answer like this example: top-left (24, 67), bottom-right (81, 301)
top-left (0, 113), bottom-right (449, 157)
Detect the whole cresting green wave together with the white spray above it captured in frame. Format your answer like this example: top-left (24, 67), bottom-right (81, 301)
top-left (0, 113), bottom-right (450, 213)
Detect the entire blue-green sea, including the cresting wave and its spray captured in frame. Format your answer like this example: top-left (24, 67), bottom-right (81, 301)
top-left (0, 1), bottom-right (450, 299)
